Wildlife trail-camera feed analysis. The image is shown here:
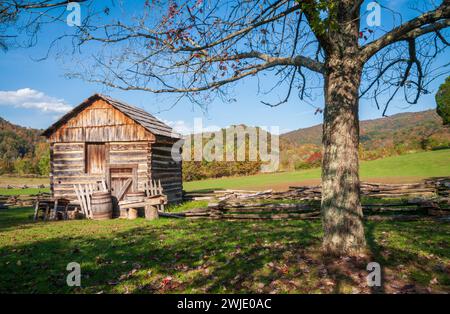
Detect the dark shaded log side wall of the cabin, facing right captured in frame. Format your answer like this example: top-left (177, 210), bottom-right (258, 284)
top-left (150, 138), bottom-right (183, 203)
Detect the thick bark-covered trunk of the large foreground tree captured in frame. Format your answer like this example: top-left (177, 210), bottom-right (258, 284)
top-left (322, 55), bottom-right (365, 255)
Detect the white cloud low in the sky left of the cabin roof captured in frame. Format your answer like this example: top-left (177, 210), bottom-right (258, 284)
top-left (0, 88), bottom-right (72, 113)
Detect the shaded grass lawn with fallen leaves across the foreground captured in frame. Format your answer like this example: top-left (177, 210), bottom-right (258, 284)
top-left (0, 208), bottom-right (450, 293)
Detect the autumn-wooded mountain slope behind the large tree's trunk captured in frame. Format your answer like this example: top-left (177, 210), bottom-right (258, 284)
top-left (280, 110), bottom-right (450, 169)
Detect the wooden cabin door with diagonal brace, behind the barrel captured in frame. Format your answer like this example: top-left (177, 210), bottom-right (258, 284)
top-left (108, 165), bottom-right (137, 202)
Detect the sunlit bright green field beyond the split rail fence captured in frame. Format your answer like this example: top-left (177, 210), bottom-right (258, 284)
top-left (184, 149), bottom-right (450, 191)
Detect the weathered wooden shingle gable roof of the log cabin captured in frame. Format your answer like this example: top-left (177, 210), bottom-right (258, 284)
top-left (42, 94), bottom-right (181, 138)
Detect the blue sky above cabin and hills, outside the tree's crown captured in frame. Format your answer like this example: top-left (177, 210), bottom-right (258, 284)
top-left (0, 0), bottom-right (450, 133)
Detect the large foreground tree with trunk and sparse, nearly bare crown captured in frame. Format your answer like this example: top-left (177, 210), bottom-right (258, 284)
top-left (4, 0), bottom-right (450, 255)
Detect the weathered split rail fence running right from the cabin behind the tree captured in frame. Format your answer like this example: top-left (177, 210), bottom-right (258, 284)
top-left (175, 178), bottom-right (450, 221)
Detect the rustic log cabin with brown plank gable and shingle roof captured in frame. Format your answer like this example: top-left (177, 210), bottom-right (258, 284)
top-left (43, 94), bottom-right (182, 203)
